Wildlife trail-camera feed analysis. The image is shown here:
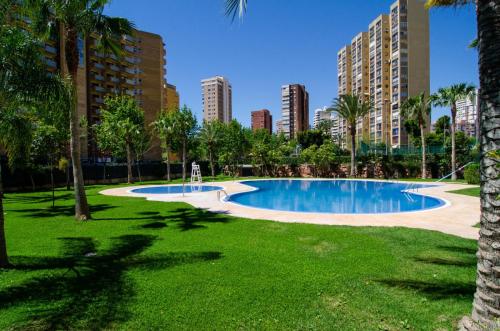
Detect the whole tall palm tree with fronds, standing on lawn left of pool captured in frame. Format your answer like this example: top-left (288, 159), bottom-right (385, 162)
top-left (23, 0), bottom-right (133, 220)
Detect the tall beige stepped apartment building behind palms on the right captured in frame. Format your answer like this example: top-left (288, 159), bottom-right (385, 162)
top-left (335, 0), bottom-right (430, 147)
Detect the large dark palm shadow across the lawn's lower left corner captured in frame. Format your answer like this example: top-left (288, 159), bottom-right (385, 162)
top-left (0, 235), bottom-right (222, 330)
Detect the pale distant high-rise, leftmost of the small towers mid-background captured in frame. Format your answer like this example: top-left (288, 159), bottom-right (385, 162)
top-left (201, 76), bottom-right (233, 123)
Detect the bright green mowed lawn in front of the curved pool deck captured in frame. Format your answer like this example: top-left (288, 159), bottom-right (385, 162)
top-left (0, 186), bottom-right (476, 330)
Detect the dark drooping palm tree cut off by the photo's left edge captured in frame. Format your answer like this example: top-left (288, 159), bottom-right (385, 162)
top-left (0, 24), bottom-right (69, 268)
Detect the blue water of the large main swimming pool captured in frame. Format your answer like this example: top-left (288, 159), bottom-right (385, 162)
top-left (229, 180), bottom-right (445, 214)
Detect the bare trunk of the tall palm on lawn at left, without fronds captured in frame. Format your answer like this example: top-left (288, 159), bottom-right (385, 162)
top-left (62, 29), bottom-right (90, 221)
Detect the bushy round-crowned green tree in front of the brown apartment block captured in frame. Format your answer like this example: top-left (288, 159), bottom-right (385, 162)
top-left (94, 95), bottom-right (146, 184)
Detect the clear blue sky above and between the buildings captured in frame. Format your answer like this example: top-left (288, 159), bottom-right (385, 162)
top-left (106, 0), bottom-right (478, 126)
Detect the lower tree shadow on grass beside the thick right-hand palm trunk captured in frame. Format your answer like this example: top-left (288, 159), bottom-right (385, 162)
top-left (376, 279), bottom-right (476, 301)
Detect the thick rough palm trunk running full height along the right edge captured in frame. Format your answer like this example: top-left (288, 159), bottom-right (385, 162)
top-left (460, 0), bottom-right (500, 330)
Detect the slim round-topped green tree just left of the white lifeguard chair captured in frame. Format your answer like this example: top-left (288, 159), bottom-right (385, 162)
top-left (173, 106), bottom-right (198, 181)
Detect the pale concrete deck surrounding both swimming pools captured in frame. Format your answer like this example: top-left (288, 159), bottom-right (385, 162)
top-left (100, 178), bottom-right (480, 239)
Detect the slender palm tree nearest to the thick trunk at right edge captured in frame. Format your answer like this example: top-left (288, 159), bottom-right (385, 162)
top-left (431, 83), bottom-right (476, 180)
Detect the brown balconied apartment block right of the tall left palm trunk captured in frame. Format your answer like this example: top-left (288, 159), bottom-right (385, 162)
top-left (85, 30), bottom-right (166, 160)
